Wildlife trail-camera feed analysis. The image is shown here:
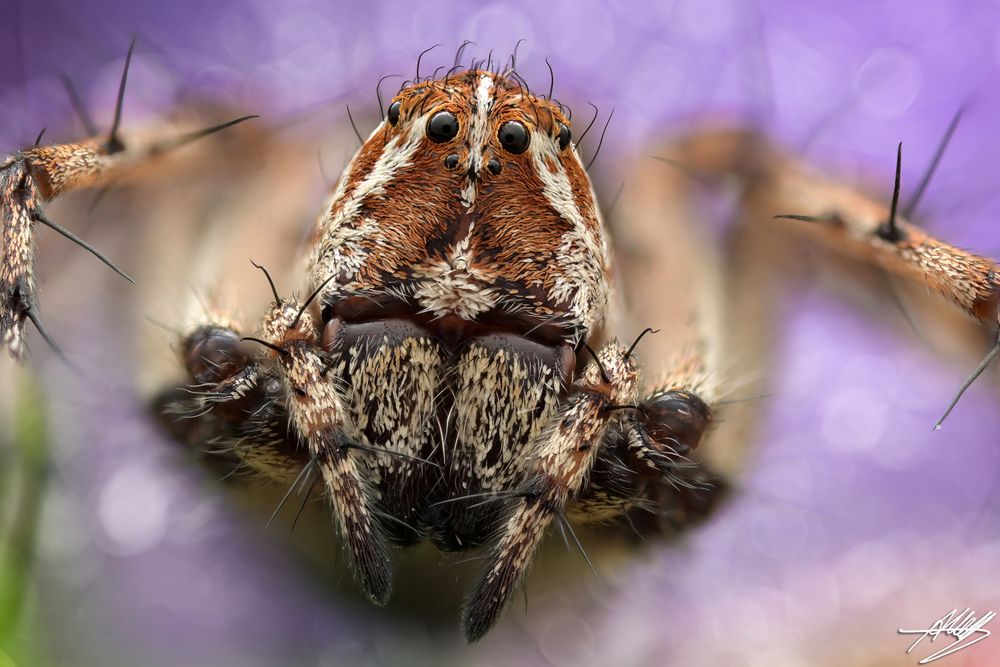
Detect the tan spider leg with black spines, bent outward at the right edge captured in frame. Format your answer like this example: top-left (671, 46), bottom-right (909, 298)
top-left (656, 127), bottom-right (1000, 428)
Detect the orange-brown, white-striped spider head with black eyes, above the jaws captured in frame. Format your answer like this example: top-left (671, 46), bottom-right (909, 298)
top-left (312, 69), bottom-right (609, 344)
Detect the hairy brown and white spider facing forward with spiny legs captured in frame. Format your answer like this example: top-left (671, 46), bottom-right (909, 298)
top-left (0, 40), bottom-right (1000, 642)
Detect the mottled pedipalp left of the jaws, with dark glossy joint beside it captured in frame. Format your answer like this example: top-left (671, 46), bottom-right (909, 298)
top-left (171, 294), bottom-right (392, 604)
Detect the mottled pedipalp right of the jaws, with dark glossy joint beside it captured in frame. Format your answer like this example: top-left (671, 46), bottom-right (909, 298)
top-left (463, 329), bottom-right (725, 641)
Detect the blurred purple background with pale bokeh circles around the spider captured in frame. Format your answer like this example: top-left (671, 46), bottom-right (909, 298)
top-left (0, 0), bottom-right (1000, 667)
